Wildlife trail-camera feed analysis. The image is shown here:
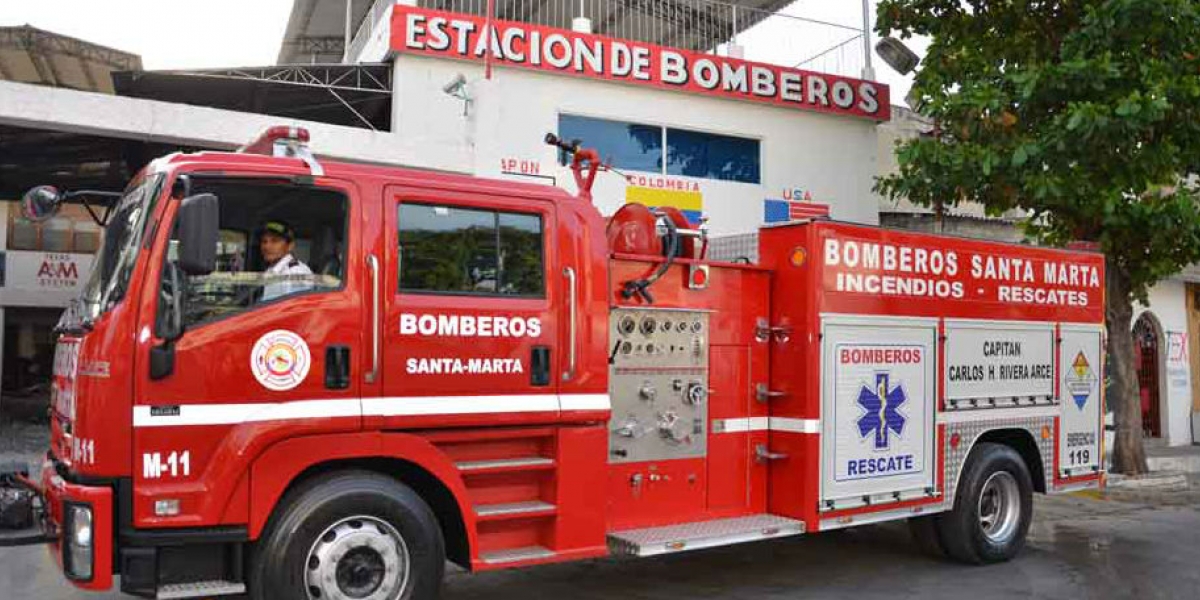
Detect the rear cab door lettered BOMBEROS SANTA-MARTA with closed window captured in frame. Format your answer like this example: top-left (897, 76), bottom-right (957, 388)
top-left (365, 186), bottom-right (563, 428)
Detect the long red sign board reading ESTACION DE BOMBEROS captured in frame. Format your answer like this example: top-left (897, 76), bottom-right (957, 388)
top-left (391, 5), bottom-right (890, 121)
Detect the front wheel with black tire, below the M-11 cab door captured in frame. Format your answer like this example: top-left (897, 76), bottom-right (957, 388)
top-left (248, 470), bottom-right (445, 600)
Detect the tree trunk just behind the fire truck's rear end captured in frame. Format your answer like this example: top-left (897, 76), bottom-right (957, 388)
top-left (1104, 259), bottom-right (1150, 475)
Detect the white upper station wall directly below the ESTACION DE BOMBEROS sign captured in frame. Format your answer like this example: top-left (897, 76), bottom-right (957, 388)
top-left (392, 54), bottom-right (878, 234)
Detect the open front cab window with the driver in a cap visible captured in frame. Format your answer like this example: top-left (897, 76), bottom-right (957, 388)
top-left (158, 178), bottom-right (348, 328)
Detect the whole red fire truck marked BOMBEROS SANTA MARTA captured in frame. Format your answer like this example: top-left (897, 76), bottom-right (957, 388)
top-left (4, 127), bottom-right (1104, 599)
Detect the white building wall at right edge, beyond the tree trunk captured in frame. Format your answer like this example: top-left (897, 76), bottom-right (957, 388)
top-left (1133, 280), bottom-right (1193, 446)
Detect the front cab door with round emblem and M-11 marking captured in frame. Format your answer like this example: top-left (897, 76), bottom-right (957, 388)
top-left (133, 176), bottom-right (366, 527)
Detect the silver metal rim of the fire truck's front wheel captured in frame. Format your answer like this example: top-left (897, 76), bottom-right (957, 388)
top-left (305, 516), bottom-right (409, 600)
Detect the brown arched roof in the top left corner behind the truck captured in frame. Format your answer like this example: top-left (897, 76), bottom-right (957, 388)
top-left (0, 25), bottom-right (142, 94)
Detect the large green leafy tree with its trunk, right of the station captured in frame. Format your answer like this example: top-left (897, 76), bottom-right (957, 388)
top-left (876, 0), bottom-right (1200, 474)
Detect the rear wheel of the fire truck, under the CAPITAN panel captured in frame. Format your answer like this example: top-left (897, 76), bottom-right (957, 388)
top-left (936, 443), bottom-right (1033, 564)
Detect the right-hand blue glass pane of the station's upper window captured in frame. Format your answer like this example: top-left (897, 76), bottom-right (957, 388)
top-left (667, 130), bottom-right (762, 184)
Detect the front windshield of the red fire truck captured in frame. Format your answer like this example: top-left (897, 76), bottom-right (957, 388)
top-left (59, 174), bottom-right (164, 330)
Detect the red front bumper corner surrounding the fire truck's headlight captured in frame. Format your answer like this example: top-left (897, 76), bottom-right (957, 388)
top-left (41, 461), bottom-right (114, 590)
